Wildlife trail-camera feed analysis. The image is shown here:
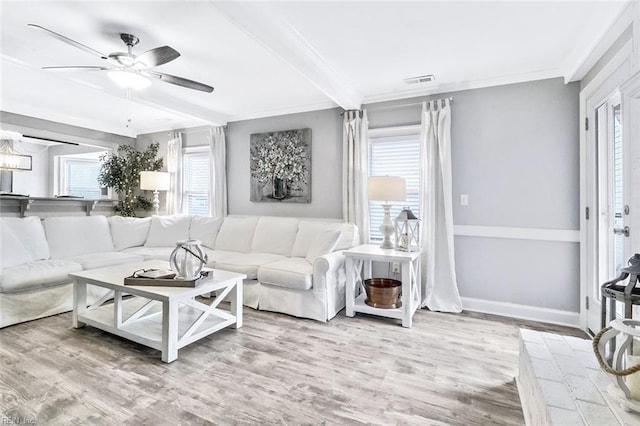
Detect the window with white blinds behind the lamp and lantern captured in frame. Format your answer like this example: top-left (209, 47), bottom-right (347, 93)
top-left (369, 126), bottom-right (421, 241)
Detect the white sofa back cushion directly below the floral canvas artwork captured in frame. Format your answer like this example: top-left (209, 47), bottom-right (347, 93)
top-left (251, 216), bottom-right (300, 256)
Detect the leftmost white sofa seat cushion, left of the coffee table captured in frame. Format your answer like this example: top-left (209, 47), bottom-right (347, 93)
top-left (0, 259), bottom-right (82, 293)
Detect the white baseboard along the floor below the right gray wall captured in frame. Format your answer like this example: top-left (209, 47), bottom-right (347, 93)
top-left (462, 297), bottom-right (580, 328)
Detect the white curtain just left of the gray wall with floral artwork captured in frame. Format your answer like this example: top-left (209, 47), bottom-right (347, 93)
top-left (209, 126), bottom-right (227, 217)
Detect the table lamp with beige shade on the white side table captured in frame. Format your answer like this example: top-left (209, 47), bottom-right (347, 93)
top-left (369, 176), bottom-right (407, 249)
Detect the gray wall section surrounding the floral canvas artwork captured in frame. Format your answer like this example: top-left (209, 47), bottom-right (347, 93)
top-left (227, 108), bottom-right (342, 218)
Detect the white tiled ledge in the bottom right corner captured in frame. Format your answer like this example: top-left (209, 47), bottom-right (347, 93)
top-left (516, 329), bottom-right (640, 426)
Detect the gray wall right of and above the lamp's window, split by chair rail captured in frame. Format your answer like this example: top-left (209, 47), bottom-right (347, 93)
top-left (366, 79), bottom-right (580, 312)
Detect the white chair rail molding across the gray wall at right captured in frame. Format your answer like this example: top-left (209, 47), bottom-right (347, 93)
top-left (453, 225), bottom-right (580, 243)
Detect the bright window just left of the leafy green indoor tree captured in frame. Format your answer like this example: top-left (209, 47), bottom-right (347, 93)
top-left (55, 152), bottom-right (106, 199)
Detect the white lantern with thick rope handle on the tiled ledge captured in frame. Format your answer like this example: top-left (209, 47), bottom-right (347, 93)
top-left (593, 319), bottom-right (640, 412)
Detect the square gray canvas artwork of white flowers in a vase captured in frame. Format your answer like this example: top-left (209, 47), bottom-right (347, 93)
top-left (250, 129), bottom-right (311, 203)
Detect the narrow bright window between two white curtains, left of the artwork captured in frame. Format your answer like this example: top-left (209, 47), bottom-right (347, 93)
top-left (182, 148), bottom-right (211, 216)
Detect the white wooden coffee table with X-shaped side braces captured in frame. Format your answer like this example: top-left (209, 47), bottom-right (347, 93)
top-left (69, 260), bottom-right (246, 362)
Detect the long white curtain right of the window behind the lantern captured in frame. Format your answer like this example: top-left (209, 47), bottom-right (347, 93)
top-left (420, 99), bottom-right (462, 312)
